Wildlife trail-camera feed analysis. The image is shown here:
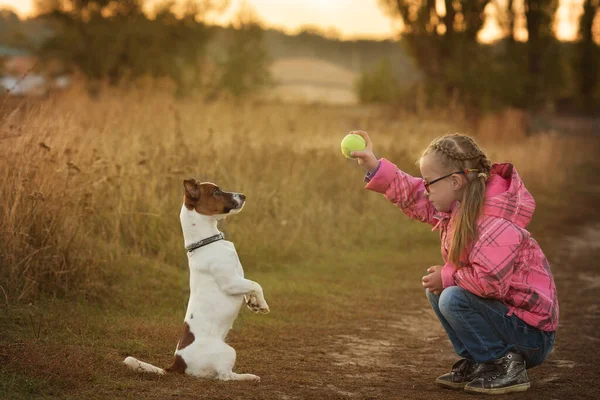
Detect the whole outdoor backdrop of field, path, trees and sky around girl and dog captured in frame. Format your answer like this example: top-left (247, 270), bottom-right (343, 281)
top-left (0, 0), bottom-right (600, 399)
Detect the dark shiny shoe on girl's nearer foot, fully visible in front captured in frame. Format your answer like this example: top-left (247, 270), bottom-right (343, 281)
top-left (465, 352), bottom-right (530, 394)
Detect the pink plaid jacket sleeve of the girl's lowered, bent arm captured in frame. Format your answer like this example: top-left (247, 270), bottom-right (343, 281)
top-left (453, 217), bottom-right (523, 300)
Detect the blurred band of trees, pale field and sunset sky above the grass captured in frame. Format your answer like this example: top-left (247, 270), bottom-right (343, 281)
top-left (0, 0), bottom-right (600, 116)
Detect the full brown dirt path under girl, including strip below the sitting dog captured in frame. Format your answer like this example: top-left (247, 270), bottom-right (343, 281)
top-left (106, 225), bottom-right (600, 400)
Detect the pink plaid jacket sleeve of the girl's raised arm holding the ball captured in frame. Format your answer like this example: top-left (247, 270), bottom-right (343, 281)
top-left (365, 158), bottom-right (438, 225)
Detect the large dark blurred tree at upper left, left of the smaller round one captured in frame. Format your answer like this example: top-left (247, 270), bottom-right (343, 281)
top-left (36, 0), bottom-right (228, 95)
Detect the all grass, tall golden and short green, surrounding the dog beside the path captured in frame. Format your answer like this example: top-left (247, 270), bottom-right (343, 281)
top-left (0, 91), bottom-right (597, 398)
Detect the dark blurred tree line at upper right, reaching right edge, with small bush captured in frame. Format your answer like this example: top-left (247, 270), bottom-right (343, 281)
top-left (358, 0), bottom-right (600, 114)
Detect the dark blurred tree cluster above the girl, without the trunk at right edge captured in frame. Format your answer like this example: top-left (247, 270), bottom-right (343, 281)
top-left (380, 0), bottom-right (568, 111)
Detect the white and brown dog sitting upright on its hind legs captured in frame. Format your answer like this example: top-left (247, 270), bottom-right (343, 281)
top-left (123, 179), bottom-right (269, 381)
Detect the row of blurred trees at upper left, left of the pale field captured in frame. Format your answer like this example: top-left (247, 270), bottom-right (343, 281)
top-left (5, 0), bottom-right (270, 96)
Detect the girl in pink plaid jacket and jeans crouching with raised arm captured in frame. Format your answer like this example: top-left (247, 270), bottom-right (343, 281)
top-left (352, 131), bottom-right (558, 394)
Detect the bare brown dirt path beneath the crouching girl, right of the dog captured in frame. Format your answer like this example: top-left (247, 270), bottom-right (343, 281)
top-left (229, 224), bottom-right (600, 400)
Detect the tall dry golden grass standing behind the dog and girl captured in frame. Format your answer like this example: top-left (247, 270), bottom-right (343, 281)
top-left (0, 86), bottom-right (593, 302)
